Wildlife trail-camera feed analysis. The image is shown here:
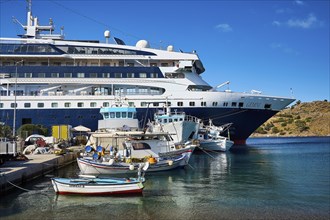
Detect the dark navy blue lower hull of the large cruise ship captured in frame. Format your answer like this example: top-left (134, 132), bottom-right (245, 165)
top-left (0, 107), bottom-right (277, 143)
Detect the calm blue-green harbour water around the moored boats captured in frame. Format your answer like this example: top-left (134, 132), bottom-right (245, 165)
top-left (0, 137), bottom-right (330, 220)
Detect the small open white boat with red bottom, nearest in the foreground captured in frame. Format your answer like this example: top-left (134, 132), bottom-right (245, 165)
top-left (51, 164), bottom-right (149, 195)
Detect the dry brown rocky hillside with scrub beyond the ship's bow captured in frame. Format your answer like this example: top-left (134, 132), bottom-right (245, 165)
top-left (252, 100), bottom-right (330, 137)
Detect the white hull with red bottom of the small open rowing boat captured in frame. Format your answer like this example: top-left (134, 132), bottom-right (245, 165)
top-left (51, 178), bottom-right (144, 195)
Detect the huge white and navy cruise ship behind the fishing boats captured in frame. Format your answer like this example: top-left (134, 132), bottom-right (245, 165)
top-left (0, 1), bottom-right (294, 144)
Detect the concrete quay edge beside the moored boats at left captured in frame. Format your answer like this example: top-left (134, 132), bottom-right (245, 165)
top-left (0, 152), bottom-right (78, 195)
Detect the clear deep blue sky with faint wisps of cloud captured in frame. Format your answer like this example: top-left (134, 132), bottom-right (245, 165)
top-left (0, 0), bottom-right (330, 102)
